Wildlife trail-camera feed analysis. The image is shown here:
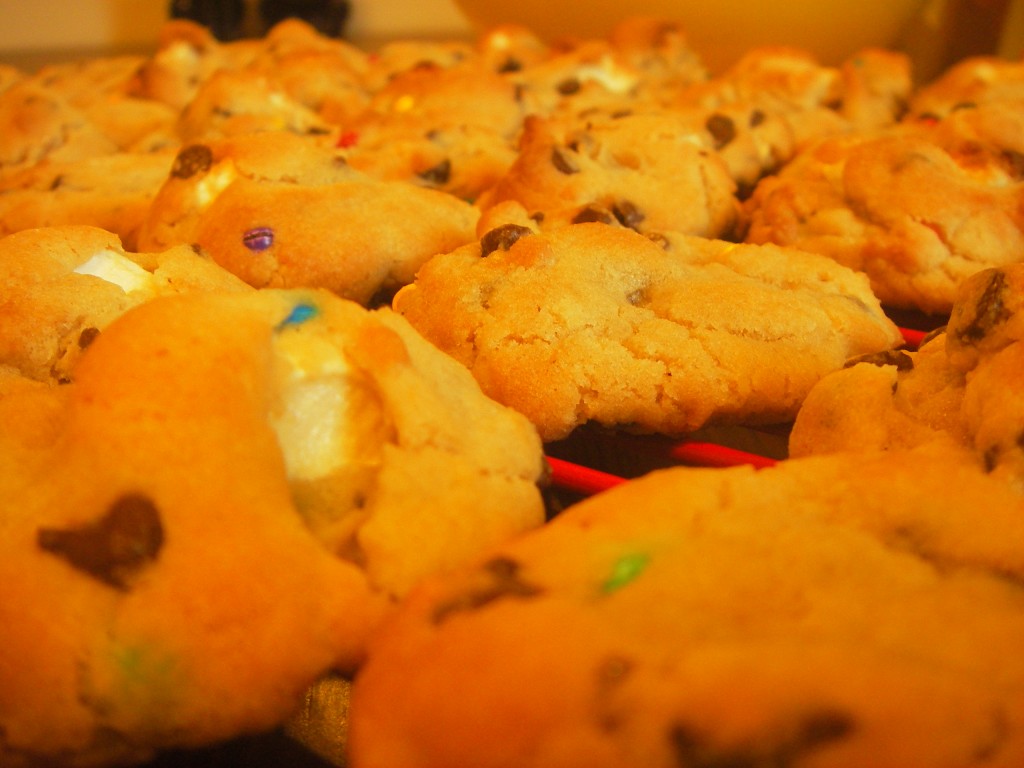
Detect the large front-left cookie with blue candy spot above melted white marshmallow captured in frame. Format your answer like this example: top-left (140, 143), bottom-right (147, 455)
top-left (0, 291), bottom-right (544, 765)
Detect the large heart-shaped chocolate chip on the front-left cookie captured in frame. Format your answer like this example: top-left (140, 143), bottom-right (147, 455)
top-left (36, 494), bottom-right (164, 591)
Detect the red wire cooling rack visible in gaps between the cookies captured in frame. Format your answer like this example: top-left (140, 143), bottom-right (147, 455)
top-left (547, 317), bottom-right (939, 497)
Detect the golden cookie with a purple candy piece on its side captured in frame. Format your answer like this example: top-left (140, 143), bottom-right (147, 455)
top-left (138, 132), bottom-right (478, 303)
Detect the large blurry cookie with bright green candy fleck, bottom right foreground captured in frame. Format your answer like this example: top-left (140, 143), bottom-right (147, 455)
top-left (349, 452), bottom-right (1024, 768)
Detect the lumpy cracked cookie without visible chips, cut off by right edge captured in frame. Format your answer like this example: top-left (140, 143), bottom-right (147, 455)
top-left (746, 101), bottom-right (1024, 314)
